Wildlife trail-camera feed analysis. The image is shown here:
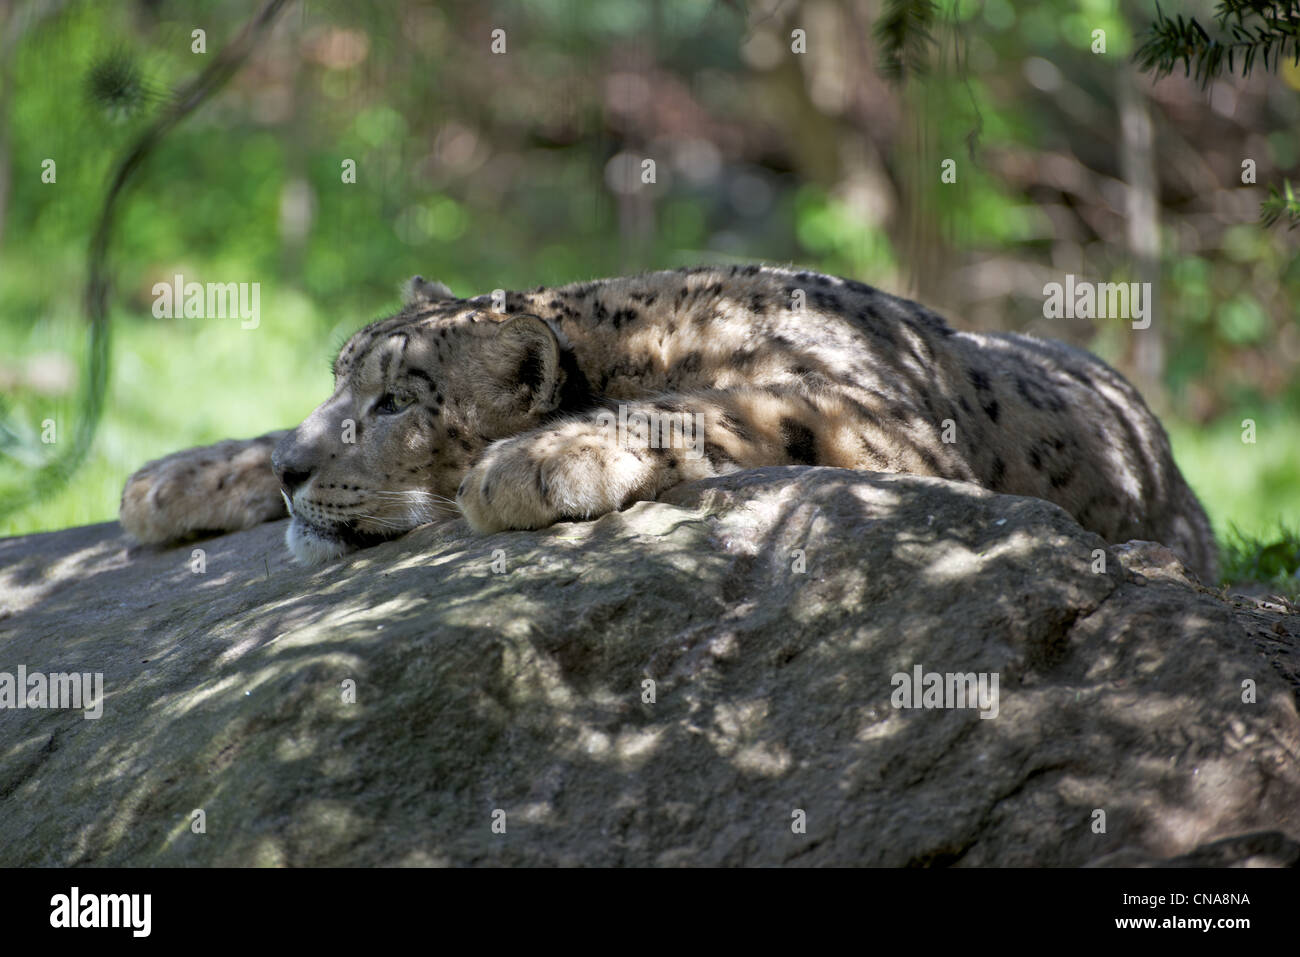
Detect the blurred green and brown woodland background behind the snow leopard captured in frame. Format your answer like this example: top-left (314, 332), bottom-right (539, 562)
top-left (0, 0), bottom-right (1300, 587)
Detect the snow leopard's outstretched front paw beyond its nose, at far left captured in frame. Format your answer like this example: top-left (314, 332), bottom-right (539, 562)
top-left (118, 433), bottom-right (287, 544)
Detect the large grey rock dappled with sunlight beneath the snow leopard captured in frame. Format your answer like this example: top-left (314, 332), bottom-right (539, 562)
top-left (0, 468), bottom-right (1300, 866)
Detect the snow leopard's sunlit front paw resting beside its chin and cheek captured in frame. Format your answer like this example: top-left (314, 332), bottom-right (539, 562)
top-left (456, 423), bottom-right (655, 534)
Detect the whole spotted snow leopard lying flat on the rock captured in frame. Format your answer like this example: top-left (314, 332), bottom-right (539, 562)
top-left (121, 265), bottom-right (1217, 580)
